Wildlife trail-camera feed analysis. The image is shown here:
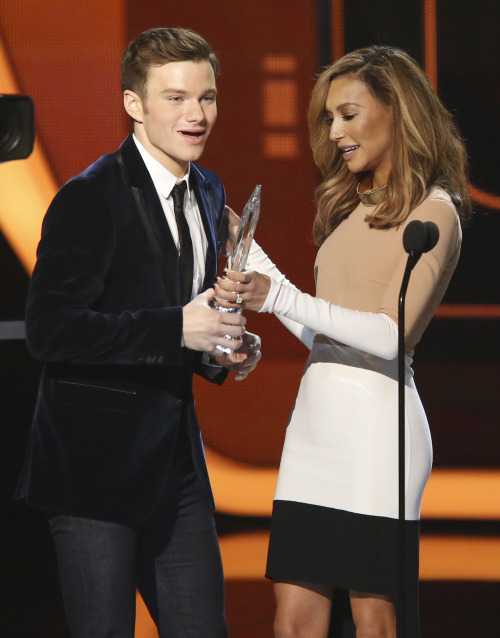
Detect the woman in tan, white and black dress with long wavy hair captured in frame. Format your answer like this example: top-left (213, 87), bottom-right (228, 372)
top-left (216, 46), bottom-right (471, 638)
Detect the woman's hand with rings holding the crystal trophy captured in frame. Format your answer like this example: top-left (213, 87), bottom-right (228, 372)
top-left (214, 270), bottom-right (271, 310)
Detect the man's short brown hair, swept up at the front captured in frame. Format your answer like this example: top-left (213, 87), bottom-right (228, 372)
top-left (121, 27), bottom-right (220, 101)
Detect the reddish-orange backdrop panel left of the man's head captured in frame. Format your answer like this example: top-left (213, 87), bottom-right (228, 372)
top-left (0, 0), bottom-right (128, 186)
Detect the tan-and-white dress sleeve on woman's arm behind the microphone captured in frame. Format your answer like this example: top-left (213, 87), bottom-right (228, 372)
top-left (260, 202), bottom-right (459, 359)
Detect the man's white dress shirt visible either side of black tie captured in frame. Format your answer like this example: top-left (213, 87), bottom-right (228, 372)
top-left (133, 135), bottom-right (208, 299)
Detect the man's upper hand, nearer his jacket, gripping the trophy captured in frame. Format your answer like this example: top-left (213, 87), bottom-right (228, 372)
top-left (182, 288), bottom-right (247, 357)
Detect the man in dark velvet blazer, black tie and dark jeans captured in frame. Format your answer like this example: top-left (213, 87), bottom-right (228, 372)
top-left (17, 29), bottom-right (260, 638)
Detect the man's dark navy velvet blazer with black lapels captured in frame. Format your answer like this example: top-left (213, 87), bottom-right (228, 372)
top-left (16, 136), bottom-right (227, 524)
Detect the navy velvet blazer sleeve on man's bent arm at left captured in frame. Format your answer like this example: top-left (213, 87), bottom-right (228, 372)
top-left (26, 178), bottom-right (183, 365)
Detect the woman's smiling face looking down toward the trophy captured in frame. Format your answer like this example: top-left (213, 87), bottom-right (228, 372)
top-left (325, 76), bottom-right (392, 188)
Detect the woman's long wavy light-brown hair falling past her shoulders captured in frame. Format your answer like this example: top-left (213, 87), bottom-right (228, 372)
top-left (308, 46), bottom-right (472, 246)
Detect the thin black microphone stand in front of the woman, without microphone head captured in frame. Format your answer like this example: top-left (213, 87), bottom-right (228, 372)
top-left (397, 250), bottom-right (421, 638)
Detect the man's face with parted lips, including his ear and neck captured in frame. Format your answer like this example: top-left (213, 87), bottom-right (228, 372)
top-left (124, 60), bottom-right (217, 177)
